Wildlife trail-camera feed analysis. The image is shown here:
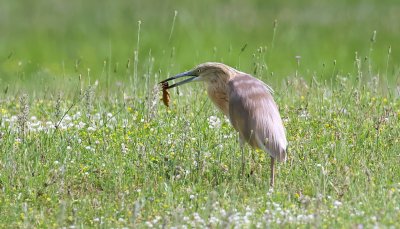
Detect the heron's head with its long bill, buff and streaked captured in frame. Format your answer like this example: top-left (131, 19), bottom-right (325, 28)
top-left (160, 62), bottom-right (238, 89)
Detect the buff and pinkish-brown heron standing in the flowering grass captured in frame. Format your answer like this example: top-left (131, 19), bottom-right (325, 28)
top-left (160, 62), bottom-right (287, 187)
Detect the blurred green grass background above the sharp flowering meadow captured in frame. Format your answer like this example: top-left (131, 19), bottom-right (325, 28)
top-left (0, 0), bottom-right (400, 91)
